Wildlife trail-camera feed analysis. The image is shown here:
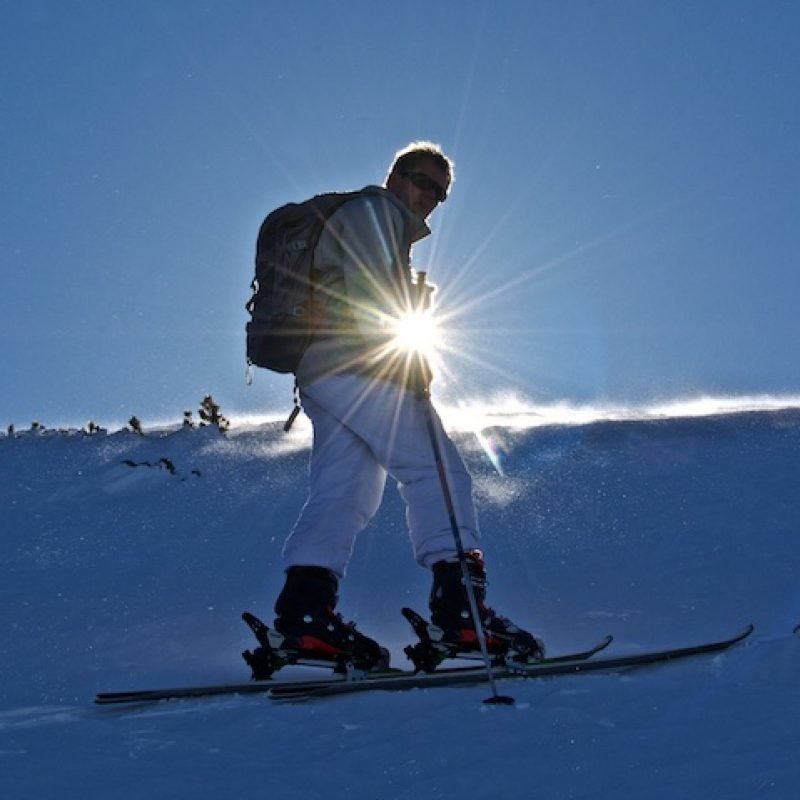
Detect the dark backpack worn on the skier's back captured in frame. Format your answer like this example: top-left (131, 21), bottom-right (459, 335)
top-left (246, 189), bottom-right (380, 373)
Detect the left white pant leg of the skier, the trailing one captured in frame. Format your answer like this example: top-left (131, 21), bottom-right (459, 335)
top-left (283, 397), bottom-right (386, 578)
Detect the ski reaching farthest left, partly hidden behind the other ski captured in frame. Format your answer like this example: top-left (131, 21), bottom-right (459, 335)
top-left (94, 636), bottom-right (612, 705)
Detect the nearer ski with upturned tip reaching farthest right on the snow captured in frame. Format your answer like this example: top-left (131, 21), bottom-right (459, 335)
top-left (269, 625), bottom-right (754, 700)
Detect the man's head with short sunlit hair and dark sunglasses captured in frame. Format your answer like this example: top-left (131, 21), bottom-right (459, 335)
top-left (386, 142), bottom-right (454, 219)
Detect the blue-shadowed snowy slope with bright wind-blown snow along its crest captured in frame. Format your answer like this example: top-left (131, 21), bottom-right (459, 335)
top-left (0, 404), bottom-right (800, 800)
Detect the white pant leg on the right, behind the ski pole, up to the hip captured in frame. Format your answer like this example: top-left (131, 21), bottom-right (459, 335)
top-left (306, 375), bottom-right (480, 567)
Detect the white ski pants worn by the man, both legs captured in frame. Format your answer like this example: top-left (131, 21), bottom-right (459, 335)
top-left (283, 375), bottom-right (480, 577)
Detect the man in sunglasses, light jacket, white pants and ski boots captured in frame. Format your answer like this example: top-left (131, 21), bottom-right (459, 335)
top-left (274, 142), bottom-right (542, 667)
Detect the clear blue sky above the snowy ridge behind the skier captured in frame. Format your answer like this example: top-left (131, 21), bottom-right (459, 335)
top-left (0, 0), bottom-right (800, 426)
